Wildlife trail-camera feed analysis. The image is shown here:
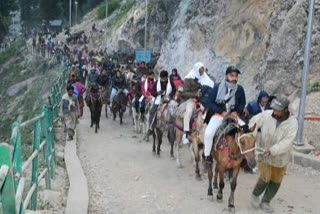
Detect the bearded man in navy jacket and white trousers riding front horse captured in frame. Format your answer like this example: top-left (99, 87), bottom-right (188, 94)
top-left (203, 66), bottom-right (246, 164)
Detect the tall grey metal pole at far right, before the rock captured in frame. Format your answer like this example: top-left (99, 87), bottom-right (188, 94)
top-left (295, 0), bottom-right (315, 146)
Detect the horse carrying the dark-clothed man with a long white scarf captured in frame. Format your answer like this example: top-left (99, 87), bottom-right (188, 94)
top-left (152, 97), bottom-right (177, 155)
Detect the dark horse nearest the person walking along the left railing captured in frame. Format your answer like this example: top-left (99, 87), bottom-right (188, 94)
top-left (86, 90), bottom-right (103, 133)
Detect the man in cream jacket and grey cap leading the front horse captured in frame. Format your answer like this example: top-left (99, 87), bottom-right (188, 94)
top-left (249, 96), bottom-right (298, 213)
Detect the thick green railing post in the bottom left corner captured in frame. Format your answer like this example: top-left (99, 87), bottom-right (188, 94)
top-left (0, 143), bottom-right (16, 214)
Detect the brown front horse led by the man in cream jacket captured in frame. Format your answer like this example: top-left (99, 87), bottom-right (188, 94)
top-left (208, 118), bottom-right (256, 212)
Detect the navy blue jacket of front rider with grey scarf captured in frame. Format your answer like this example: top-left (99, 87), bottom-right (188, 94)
top-left (202, 83), bottom-right (246, 115)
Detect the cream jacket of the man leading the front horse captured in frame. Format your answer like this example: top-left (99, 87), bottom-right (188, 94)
top-left (249, 110), bottom-right (298, 167)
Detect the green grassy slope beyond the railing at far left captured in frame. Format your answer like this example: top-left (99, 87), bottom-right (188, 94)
top-left (0, 39), bottom-right (61, 142)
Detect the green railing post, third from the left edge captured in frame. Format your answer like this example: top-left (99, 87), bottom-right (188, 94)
top-left (31, 120), bottom-right (41, 210)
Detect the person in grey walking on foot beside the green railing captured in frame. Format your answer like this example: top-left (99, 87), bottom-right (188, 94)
top-left (60, 85), bottom-right (79, 140)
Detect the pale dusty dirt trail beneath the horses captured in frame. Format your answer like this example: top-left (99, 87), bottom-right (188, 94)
top-left (79, 108), bottom-right (320, 214)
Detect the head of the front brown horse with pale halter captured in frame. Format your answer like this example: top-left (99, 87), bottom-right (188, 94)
top-left (235, 125), bottom-right (256, 168)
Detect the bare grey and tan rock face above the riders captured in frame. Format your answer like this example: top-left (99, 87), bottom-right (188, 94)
top-left (75, 0), bottom-right (320, 99)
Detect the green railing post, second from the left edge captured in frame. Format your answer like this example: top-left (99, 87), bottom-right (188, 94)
top-left (10, 122), bottom-right (21, 188)
